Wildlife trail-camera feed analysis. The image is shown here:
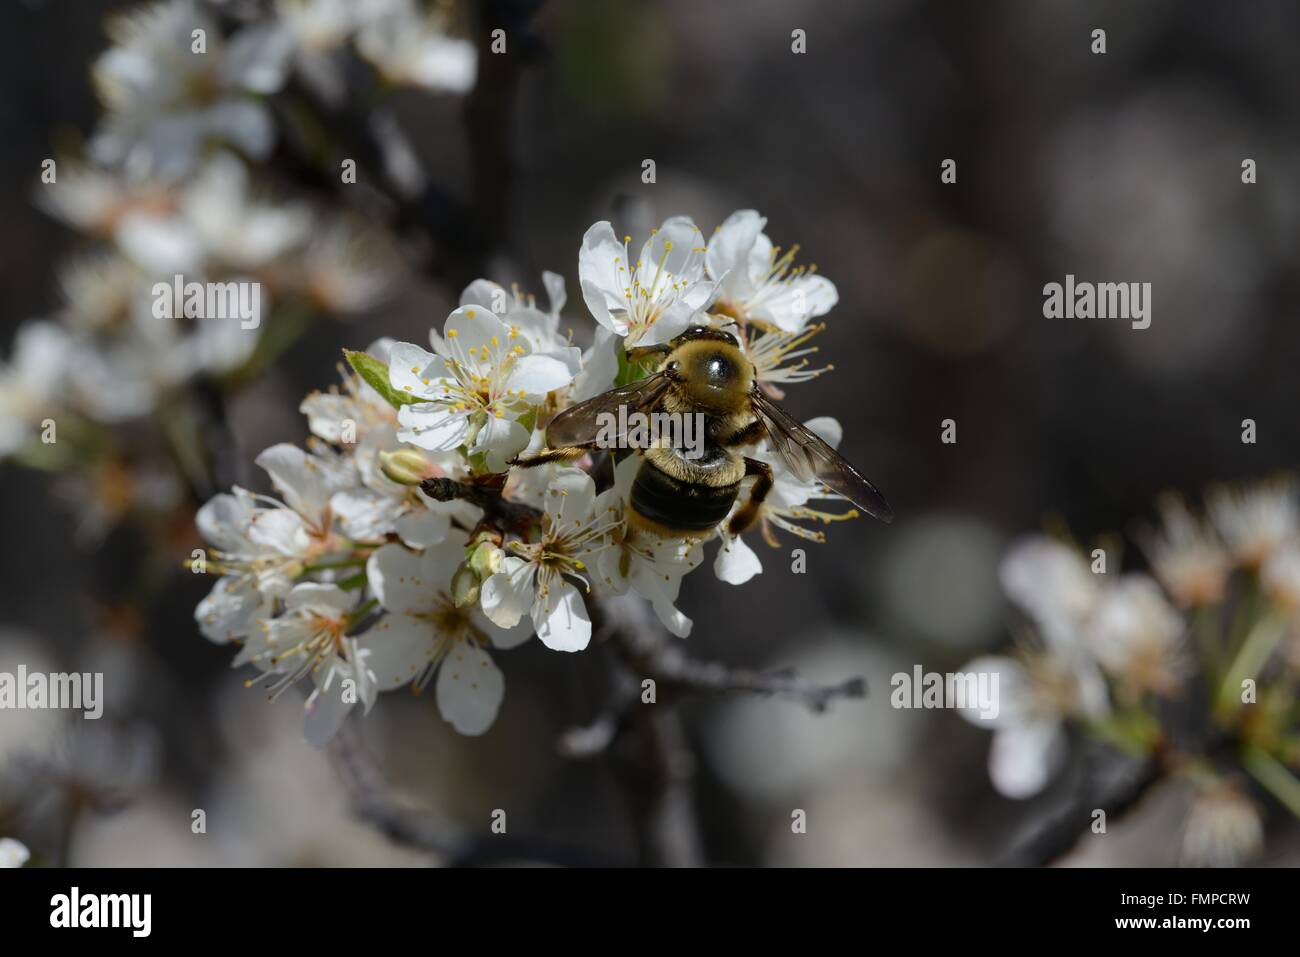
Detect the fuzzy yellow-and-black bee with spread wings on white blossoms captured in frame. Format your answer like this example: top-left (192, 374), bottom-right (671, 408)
top-left (512, 326), bottom-right (893, 538)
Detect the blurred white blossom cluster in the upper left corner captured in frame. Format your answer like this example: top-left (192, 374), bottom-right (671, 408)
top-left (0, 0), bottom-right (476, 527)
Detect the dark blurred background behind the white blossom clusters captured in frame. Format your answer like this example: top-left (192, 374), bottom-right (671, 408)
top-left (0, 0), bottom-right (1300, 866)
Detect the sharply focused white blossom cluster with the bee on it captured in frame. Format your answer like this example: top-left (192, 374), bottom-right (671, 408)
top-left (194, 211), bottom-right (855, 744)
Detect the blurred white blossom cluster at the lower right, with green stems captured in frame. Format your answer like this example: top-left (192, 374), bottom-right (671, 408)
top-left (963, 479), bottom-right (1300, 863)
